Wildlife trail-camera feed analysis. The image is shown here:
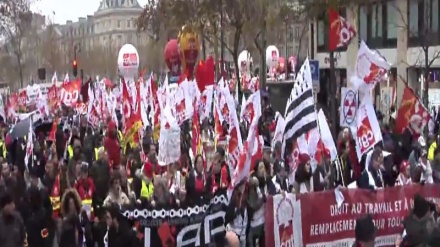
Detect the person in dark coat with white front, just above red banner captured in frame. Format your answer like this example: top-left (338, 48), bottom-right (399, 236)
top-left (357, 148), bottom-right (385, 190)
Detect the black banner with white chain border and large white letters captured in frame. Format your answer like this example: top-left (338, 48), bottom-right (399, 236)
top-left (121, 190), bottom-right (229, 247)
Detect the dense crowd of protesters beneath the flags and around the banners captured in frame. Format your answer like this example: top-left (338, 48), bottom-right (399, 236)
top-left (0, 102), bottom-right (440, 247)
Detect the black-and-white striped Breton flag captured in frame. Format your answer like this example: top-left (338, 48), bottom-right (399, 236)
top-left (283, 58), bottom-right (318, 155)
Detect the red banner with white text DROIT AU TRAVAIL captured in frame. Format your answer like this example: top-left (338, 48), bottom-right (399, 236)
top-left (296, 185), bottom-right (440, 247)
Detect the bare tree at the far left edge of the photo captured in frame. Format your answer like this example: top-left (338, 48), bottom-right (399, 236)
top-left (0, 0), bottom-right (32, 87)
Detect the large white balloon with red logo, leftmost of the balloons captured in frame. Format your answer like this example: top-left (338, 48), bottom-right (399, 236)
top-left (118, 44), bottom-right (139, 81)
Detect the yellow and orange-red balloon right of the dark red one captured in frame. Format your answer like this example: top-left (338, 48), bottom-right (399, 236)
top-left (177, 26), bottom-right (200, 78)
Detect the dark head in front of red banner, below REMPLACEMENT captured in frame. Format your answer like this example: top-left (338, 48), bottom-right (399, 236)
top-left (352, 215), bottom-right (377, 247)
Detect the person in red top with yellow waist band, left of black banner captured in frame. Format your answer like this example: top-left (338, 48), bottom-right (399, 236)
top-left (74, 163), bottom-right (96, 220)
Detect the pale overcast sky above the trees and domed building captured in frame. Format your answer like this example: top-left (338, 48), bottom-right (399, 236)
top-left (32, 0), bottom-right (147, 24)
